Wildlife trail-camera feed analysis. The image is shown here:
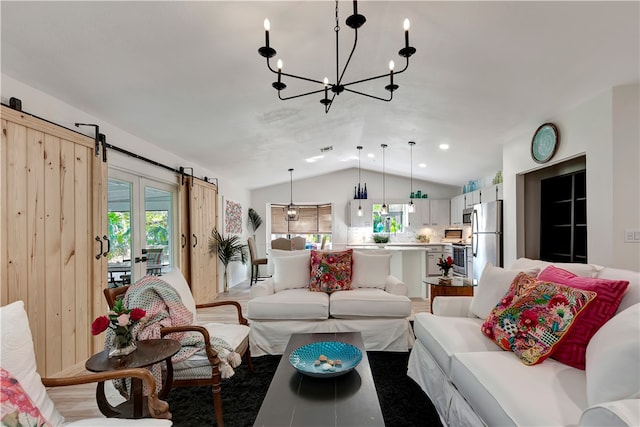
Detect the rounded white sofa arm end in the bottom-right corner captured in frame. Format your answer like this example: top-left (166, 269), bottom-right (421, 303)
top-left (580, 399), bottom-right (640, 427)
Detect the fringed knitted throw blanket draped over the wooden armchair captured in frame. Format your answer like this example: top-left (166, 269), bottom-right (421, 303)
top-left (105, 276), bottom-right (240, 396)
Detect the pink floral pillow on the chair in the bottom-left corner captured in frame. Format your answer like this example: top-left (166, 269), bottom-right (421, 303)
top-left (0, 368), bottom-right (51, 427)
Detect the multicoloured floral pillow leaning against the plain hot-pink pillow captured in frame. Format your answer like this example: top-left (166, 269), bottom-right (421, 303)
top-left (482, 274), bottom-right (597, 365)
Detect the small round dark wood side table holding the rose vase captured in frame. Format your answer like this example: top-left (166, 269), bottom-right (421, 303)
top-left (85, 339), bottom-right (180, 418)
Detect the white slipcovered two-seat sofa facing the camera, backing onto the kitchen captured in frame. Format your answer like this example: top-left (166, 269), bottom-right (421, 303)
top-left (247, 251), bottom-right (414, 356)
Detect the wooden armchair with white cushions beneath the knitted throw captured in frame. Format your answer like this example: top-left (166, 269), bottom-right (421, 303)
top-left (103, 268), bottom-right (253, 427)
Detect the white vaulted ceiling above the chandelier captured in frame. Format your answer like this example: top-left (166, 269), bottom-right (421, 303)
top-left (0, 0), bottom-right (640, 189)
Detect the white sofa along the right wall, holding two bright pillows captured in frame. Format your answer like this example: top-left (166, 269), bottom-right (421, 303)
top-left (408, 258), bottom-right (640, 426)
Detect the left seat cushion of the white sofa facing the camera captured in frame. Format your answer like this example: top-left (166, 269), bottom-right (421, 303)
top-left (247, 288), bottom-right (329, 320)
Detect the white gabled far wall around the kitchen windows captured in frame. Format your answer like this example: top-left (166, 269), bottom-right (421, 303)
top-left (251, 168), bottom-right (460, 256)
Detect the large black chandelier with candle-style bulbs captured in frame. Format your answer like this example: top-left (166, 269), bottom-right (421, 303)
top-left (258, 0), bottom-right (416, 113)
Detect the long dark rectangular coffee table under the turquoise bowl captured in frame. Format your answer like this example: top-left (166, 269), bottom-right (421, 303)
top-left (254, 332), bottom-right (384, 427)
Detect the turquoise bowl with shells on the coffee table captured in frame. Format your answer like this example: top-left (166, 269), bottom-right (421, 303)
top-left (289, 341), bottom-right (362, 378)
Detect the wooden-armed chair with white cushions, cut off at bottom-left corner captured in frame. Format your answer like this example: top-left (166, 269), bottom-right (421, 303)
top-left (0, 301), bottom-right (172, 427)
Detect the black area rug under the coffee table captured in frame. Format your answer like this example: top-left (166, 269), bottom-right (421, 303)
top-left (167, 352), bottom-right (442, 427)
